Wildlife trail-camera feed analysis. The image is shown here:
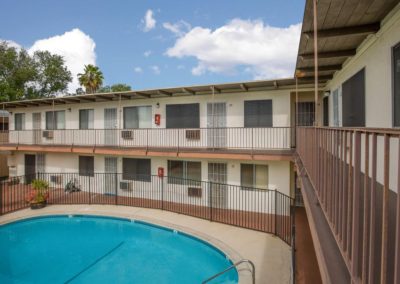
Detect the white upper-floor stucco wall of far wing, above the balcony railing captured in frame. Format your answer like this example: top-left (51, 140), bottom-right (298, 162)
top-left (10, 90), bottom-right (290, 130)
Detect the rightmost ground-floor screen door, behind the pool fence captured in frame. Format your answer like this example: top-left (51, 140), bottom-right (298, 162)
top-left (208, 163), bottom-right (228, 208)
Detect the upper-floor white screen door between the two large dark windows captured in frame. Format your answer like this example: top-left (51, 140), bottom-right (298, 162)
top-left (207, 103), bottom-right (227, 148)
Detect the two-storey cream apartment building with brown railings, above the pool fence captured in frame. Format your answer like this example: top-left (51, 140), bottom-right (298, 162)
top-left (0, 0), bottom-right (400, 283)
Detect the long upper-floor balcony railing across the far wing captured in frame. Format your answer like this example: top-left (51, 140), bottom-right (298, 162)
top-left (0, 127), bottom-right (294, 151)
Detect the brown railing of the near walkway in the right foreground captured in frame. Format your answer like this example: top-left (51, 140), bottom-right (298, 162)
top-left (296, 127), bottom-right (400, 283)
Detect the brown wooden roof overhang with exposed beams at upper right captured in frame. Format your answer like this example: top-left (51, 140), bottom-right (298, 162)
top-left (295, 0), bottom-right (399, 83)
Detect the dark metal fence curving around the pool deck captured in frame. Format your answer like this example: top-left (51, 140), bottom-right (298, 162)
top-left (0, 173), bottom-right (294, 245)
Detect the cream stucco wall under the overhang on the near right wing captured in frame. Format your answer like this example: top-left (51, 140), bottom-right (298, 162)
top-left (326, 4), bottom-right (400, 127)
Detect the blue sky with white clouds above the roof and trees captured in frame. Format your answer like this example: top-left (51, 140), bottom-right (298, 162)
top-left (0, 0), bottom-right (304, 92)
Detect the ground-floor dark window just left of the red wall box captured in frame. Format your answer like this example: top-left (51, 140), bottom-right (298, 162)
top-left (122, 158), bottom-right (151, 182)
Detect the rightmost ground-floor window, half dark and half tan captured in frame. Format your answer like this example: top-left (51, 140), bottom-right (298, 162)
top-left (240, 164), bottom-right (268, 189)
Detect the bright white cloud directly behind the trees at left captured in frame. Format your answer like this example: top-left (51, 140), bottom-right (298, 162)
top-left (28, 29), bottom-right (96, 92)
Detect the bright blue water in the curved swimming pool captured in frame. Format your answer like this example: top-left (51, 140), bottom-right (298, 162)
top-left (0, 216), bottom-right (238, 284)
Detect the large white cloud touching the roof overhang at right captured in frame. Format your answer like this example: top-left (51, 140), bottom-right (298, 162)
top-left (166, 19), bottom-right (301, 79)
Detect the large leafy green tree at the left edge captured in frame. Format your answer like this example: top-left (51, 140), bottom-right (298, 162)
top-left (0, 41), bottom-right (72, 101)
